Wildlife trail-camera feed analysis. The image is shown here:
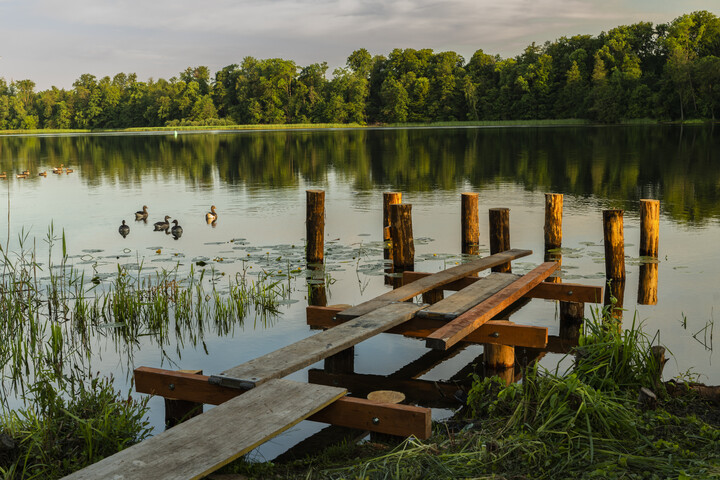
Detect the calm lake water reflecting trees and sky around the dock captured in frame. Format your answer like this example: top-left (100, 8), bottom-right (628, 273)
top-left (0, 127), bottom-right (720, 458)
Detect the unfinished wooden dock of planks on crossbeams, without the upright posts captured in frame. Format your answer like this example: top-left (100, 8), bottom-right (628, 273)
top-left (66, 250), bottom-right (602, 480)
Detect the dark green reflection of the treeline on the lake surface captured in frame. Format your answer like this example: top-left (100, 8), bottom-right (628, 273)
top-left (0, 126), bottom-right (720, 223)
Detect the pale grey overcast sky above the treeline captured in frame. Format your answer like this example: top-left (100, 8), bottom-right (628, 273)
top-left (0, 0), bottom-right (720, 91)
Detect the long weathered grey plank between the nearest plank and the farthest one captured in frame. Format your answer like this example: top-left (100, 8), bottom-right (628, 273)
top-left (217, 302), bottom-right (422, 389)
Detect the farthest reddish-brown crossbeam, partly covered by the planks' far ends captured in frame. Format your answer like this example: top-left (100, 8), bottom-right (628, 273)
top-left (403, 272), bottom-right (603, 303)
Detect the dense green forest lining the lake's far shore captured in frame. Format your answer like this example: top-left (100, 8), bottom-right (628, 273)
top-left (0, 11), bottom-right (720, 130)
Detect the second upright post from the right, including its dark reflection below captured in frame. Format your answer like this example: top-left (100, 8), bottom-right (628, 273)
top-left (603, 210), bottom-right (625, 320)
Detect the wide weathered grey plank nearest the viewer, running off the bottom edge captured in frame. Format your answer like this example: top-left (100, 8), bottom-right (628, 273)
top-left (65, 379), bottom-right (346, 480)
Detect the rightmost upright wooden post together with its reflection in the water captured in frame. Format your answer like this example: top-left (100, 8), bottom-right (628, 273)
top-left (638, 199), bottom-right (660, 305)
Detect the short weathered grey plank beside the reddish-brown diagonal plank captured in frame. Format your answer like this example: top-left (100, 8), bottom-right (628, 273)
top-left (417, 272), bottom-right (519, 320)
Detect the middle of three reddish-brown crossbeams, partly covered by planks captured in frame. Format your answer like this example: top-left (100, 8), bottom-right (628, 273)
top-left (306, 307), bottom-right (548, 348)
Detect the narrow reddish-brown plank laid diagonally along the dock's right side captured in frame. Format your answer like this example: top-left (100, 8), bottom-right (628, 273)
top-left (425, 262), bottom-right (558, 350)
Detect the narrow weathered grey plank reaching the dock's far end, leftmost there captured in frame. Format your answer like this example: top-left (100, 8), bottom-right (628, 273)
top-left (340, 249), bottom-right (532, 319)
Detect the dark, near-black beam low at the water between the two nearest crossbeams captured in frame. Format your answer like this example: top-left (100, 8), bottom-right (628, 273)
top-left (308, 368), bottom-right (464, 408)
